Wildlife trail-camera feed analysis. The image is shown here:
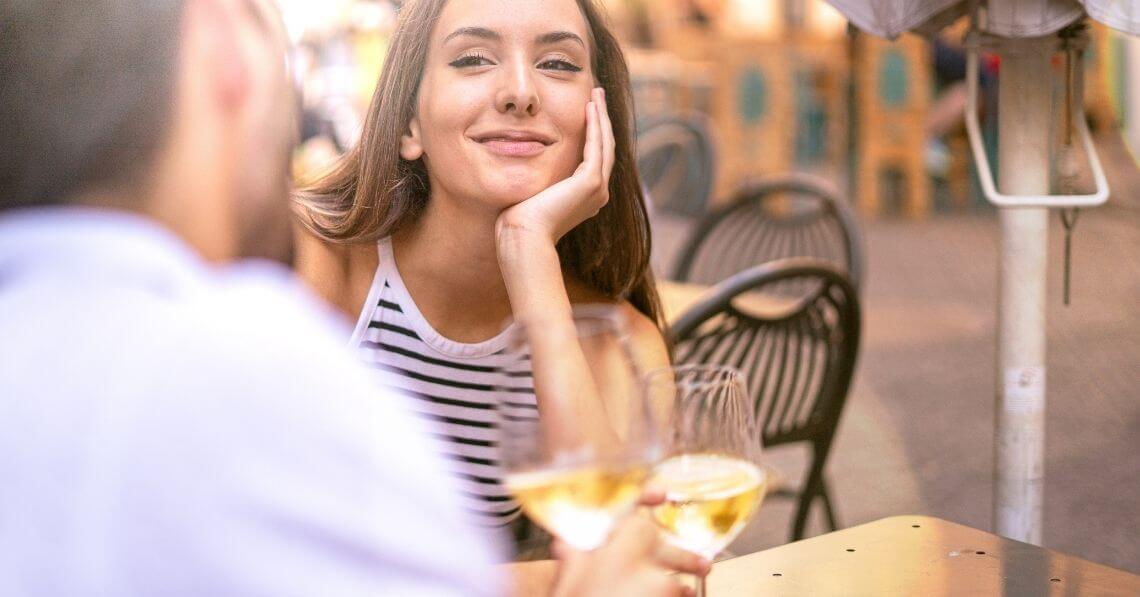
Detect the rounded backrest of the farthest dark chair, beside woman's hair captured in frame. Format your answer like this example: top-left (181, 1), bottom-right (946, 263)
top-left (637, 115), bottom-right (716, 216)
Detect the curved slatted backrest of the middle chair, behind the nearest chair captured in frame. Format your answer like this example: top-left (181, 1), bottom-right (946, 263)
top-left (673, 173), bottom-right (863, 288)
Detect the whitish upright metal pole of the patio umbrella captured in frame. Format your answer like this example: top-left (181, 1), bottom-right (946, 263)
top-left (994, 35), bottom-right (1056, 545)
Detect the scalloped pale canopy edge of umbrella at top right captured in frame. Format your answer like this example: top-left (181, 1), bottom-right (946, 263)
top-left (828, 0), bottom-right (1140, 38)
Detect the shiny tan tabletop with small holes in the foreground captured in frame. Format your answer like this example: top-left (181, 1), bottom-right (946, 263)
top-left (707, 510), bottom-right (1140, 597)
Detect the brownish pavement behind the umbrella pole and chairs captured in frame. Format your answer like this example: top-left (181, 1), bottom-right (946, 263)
top-left (654, 135), bottom-right (1140, 573)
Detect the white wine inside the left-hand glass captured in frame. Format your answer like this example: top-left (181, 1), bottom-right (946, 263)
top-left (506, 465), bottom-right (649, 550)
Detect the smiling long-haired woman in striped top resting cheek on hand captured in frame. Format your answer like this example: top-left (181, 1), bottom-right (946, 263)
top-left (298, 0), bottom-right (668, 587)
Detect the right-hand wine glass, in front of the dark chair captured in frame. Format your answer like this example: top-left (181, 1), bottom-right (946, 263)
top-left (646, 365), bottom-right (767, 596)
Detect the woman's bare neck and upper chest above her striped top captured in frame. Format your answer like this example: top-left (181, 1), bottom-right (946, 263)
top-left (392, 191), bottom-right (511, 342)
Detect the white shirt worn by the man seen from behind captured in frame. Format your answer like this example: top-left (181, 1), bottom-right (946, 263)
top-left (0, 208), bottom-right (500, 597)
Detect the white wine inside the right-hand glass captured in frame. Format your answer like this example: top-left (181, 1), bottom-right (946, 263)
top-left (653, 453), bottom-right (766, 558)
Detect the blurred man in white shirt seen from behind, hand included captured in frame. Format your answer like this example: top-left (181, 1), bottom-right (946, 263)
top-left (0, 0), bottom-right (676, 596)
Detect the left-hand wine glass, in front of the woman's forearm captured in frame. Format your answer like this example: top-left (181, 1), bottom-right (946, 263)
top-left (496, 305), bottom-right (661, 550)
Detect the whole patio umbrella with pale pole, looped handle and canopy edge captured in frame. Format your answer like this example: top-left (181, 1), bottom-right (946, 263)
top-left (828, 0), bottom-right (1140, 545)
